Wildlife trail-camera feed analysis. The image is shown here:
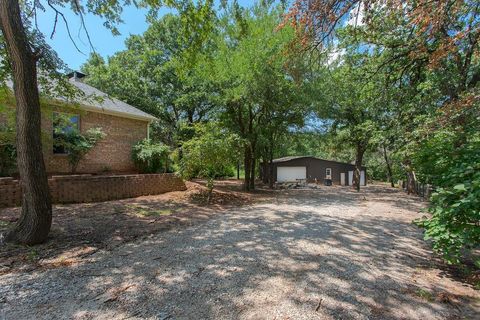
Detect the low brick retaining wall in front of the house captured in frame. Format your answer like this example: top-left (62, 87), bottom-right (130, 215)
top-left (0, 173), bottom-right (186, 208)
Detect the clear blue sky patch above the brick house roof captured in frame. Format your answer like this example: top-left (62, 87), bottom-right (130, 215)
top-left (38, 0), bottom-right (253, 70)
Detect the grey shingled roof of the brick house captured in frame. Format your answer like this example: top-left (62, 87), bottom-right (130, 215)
top-left (70, 77), bottom-right (156, 121)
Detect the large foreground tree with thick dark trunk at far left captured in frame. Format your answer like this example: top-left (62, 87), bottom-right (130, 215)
top-left (0, 0), bottom-right (212, 244)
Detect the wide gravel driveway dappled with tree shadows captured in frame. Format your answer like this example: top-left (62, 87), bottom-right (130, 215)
top-left (0, 186), bottom-right (480, 319)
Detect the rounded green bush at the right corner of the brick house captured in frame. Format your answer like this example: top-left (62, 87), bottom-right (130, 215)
top-left (132, 139), bottom-right (170, 173)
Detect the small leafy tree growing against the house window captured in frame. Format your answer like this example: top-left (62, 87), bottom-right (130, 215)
top-left (54, 127), bottom-right (105, 173)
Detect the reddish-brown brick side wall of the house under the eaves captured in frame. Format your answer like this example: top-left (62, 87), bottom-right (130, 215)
top-left (42, 109), bottom-right (148, 173)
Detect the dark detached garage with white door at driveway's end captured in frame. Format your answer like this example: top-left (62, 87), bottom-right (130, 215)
top-left (273, 156), bottom-right (367, 186)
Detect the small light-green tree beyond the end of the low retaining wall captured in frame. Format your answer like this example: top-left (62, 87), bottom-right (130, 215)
top-left (180, 123), bottom-right (240, 203)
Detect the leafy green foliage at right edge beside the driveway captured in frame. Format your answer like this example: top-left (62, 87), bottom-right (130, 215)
top-left (415, 106), bottom-right (480, 263)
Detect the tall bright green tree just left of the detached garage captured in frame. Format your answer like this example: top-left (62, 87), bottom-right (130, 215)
top-left (212, 6), bottom-right (305, 190)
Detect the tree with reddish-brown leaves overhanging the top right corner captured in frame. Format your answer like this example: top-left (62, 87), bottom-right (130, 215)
top-left (284, 0), bottom-right (480, 191)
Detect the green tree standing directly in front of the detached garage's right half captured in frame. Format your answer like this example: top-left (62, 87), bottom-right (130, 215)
top-left (317, 52), bottom-right (383, 191)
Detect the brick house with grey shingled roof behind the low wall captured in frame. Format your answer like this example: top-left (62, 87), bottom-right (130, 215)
top-left (4, 72), bottom-right (156, 174)
